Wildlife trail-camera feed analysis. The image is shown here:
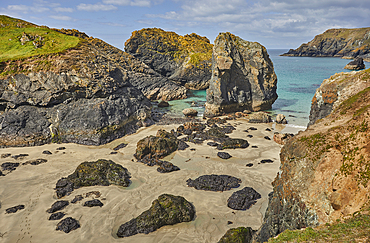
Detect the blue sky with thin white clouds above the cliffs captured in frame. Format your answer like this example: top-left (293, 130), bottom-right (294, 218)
top-left (0, 0), bottom-right (370, 49)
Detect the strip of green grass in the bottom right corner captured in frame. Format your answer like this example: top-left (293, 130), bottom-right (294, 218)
top-left (268, 212), bottom-right (370, 243)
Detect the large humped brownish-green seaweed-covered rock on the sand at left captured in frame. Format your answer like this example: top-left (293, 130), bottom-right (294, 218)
top-left (55, 159), bottom-right (131, 198)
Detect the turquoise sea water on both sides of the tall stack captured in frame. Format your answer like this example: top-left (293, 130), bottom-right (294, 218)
top-left (162, 49), bottom-right (370, 126)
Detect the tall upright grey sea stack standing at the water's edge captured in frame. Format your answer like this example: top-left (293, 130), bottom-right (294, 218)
top-left (205, 32), bottom-right (278, 117)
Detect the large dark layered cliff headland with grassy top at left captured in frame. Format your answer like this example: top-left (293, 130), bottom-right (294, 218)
top-left (0, 16), bottom-right (165, 147)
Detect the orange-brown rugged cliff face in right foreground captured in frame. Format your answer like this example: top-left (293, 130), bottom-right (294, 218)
top-left (258, 69), bottom-right (370, 241)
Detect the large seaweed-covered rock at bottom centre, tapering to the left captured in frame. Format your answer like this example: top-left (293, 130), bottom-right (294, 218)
top-left (117, 194), bottom-right (195, 237)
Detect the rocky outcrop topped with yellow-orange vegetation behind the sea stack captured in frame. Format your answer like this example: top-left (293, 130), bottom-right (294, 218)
top-left (125, 28), bottom-right (212, 90)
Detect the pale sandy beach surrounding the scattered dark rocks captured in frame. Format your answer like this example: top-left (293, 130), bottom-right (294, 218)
top-left (0, 118), bottom-right (304, 242)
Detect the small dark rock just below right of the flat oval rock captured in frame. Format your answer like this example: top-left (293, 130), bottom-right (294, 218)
top-left (227, 187), bottom-right (261, 210)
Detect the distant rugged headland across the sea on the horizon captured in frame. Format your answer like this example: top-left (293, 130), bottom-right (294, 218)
top-left (283, 28), bottom-right (370, 61)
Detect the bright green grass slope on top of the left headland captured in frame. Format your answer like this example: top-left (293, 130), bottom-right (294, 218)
top-left (0, 15), bottom-right (80, 62)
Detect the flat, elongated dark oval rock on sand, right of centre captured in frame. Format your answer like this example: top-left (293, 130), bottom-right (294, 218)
top-left (186, 175), bottom-right (242, 191)
